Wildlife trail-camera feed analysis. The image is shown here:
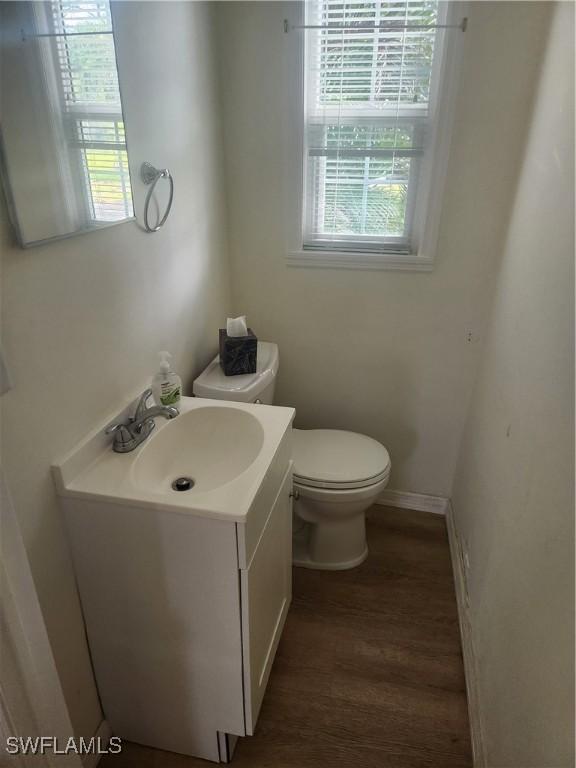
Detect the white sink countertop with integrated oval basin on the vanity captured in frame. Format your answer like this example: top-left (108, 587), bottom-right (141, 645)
top-left (53, 397), bottom-right (294, 522)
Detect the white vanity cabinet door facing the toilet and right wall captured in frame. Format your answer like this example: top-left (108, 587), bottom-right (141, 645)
top-left (240, 466), bottom-right (292, 735)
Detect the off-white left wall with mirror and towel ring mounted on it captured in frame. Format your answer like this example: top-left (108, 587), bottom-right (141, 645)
top-left (0, 2), bottom-right (229, 736)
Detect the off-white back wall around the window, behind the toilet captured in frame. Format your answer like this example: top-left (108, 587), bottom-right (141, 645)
top-left (218, 2), bottom-right (548, 495)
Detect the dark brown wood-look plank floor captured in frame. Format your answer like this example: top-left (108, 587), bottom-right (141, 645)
top-left (100, 507), bottom-right (472, 768)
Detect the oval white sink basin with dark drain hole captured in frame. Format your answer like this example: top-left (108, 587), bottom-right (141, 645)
top-left (132, 406), bottom-right (264, 496)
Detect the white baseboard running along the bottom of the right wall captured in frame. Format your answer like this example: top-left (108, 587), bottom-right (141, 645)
top-left (446, 501), bottom-right (487, 768)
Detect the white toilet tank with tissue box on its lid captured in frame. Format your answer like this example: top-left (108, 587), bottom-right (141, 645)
top-left (192, 341), bottom-right (279, 405)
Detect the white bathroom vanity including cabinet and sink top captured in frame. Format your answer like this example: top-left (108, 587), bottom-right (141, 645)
top-left (54, 398), bottom-right (294, 762)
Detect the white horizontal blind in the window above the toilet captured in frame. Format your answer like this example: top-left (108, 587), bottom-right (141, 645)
top-left (303, 0), bottom-right (439, 254)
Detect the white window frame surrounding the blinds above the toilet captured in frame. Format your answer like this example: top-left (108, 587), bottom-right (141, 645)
top-left (283, 0), bottom-right (466, 271)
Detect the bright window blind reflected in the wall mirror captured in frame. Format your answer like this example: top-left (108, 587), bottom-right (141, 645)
top-left (51, 0), bottom-right (133, 223)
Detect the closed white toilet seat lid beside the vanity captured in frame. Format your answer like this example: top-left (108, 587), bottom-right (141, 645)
top-left (292, 429), bottom-right (390, 491)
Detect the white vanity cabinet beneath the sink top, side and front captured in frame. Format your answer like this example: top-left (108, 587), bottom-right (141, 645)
top-left (62, 429), bottom-right (292, 762)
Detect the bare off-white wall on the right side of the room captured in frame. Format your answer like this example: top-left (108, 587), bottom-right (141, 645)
top-left (453, 3), bottom-right (574, 768)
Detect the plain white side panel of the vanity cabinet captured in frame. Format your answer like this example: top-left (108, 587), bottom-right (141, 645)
top-left (64, 499), bottom-right (244, 761)
